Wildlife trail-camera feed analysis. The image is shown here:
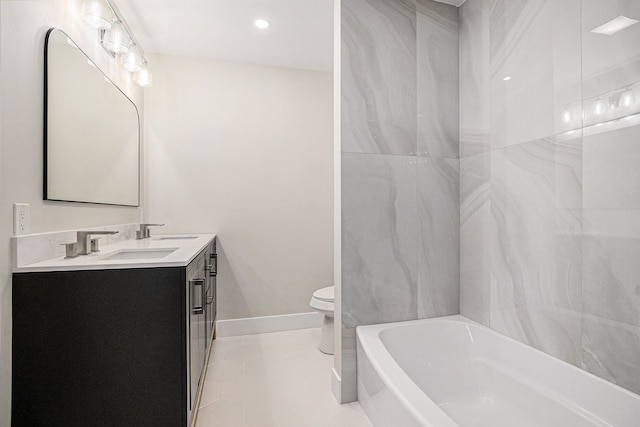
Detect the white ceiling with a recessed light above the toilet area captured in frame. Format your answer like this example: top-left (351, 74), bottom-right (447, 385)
top-left (115, 0), bottom-right (333, 72)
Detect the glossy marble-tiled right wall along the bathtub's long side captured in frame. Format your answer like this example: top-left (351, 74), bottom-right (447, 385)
top-left (459, 0), bottom-right (640, 393)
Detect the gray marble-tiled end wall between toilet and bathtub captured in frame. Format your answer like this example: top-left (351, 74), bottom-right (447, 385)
top-left (341, 0), bottom-right (460, 401)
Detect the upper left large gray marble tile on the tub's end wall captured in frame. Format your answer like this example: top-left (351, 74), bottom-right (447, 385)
top-left (341, 0), bottom-right (417, 155)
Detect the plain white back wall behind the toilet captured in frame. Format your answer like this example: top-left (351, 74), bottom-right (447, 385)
top-left (145, 55), bottom-right (333, 319)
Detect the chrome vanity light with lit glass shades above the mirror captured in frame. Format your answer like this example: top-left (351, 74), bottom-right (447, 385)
top-left (82, 0), bottom-right (153, 87)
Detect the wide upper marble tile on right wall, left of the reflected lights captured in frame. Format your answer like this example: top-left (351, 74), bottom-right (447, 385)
top-left (489, 0), bottom-right (581, 148)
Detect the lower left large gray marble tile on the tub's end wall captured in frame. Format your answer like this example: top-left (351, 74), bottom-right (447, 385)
top-left (342, 153), bottom-right (418, 327)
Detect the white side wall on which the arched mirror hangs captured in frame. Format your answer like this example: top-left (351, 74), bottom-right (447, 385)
top-left (0, 0), bottom-right (142, 426)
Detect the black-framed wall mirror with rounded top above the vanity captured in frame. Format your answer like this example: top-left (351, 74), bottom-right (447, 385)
top-left (44, 28), bottom-right (140, 206)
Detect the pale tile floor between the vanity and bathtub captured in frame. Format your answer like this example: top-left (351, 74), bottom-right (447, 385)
top-left (197, 328), bottom-right (371, 427)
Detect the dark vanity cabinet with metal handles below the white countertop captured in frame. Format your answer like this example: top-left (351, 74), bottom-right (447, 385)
top-left (11, 240), bottom-right (215, 427)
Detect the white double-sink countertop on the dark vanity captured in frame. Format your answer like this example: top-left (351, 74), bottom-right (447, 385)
top-left (13, 233), bottom-right (215, 273)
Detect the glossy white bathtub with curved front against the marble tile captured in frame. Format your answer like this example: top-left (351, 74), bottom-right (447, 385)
top-left (357, 316), bottom-right (640, 427)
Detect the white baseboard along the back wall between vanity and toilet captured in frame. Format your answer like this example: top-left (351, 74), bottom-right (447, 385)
top-left (216, 311), bottom-right (324, 337)
